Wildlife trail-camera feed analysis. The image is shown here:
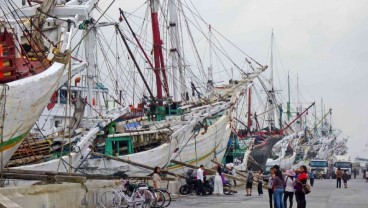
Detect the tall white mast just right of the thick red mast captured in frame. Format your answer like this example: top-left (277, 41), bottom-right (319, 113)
top-left (168, 0), bottom-right (185, 102)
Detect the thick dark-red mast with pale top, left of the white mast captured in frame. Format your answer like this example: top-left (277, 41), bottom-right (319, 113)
top-left (150, 0), bottom-right (169, 106)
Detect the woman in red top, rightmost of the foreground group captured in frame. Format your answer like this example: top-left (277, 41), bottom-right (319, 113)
top-left (295, 165), bottom-right (308, 208)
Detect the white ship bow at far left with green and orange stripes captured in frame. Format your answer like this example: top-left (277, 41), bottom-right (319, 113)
top-left (0, 62), bottom-right (65, 166)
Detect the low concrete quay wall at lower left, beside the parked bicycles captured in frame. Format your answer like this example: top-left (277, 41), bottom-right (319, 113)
top-left (0, 180), bottom-right (180, 208)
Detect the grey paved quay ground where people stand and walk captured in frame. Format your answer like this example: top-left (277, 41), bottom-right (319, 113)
top-left (170, 178), bottom-right (368, 208)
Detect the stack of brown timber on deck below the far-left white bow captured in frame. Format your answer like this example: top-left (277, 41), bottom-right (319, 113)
top-left (6, 137), bottom-right (51, 167)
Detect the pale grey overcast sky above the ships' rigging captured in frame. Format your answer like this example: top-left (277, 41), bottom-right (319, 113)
top-left (103, 0), bottom-right (368, 157)
